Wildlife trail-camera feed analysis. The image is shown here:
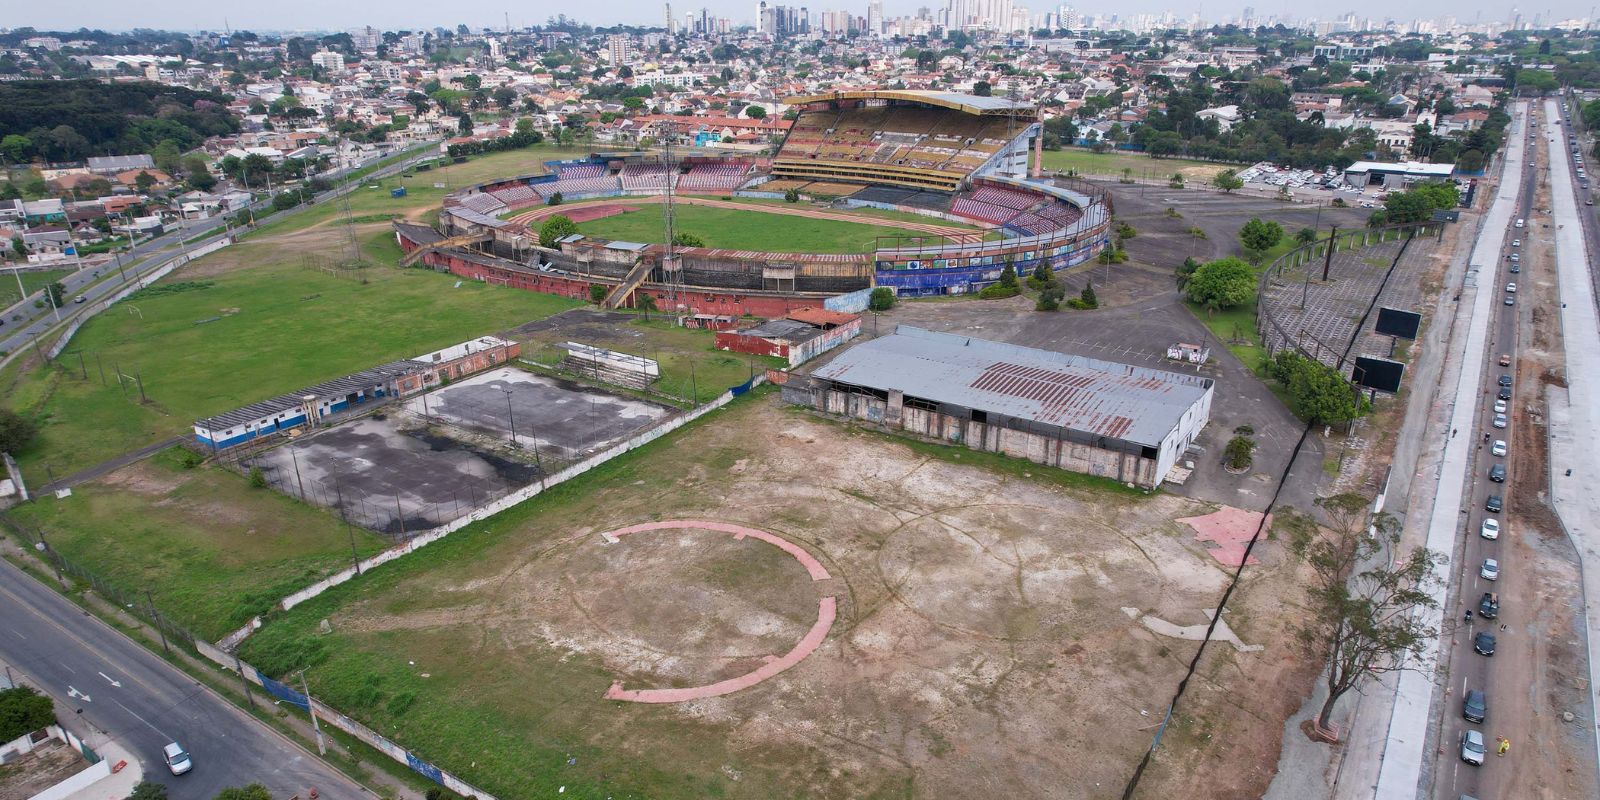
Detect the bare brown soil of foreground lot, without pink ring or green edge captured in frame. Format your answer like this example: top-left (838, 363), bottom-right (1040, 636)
top-left (333, 398), bottom-right (1309, 798)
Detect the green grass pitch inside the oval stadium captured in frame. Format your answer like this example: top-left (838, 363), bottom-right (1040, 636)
top-left (578, 205), bottom-right (906, 253)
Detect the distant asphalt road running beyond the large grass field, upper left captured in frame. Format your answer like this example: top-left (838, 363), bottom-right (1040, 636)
top-left (0, 147), bottom-right (437, 358)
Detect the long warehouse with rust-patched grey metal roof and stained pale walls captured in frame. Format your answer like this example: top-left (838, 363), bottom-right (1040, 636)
top-left (782, 325), bottom-right (1213, 488)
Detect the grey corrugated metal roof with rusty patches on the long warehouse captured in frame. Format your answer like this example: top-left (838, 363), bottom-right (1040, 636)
top-left (813, 325), bottom-right (1211, 446)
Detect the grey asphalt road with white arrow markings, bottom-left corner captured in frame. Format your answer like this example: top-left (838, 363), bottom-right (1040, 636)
top-left (0, 562), bottom-right (373, 800)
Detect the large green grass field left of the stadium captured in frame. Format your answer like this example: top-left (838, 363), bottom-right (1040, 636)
top-left (8, 230), bottom-right (578, 482)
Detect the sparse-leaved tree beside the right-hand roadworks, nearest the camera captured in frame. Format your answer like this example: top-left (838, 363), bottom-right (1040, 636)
top-left (1274, 493), bottom-right (1440, 731)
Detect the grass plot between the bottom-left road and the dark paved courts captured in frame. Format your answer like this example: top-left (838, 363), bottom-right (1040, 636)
top-left (8, 450), bottom-right (384, 642)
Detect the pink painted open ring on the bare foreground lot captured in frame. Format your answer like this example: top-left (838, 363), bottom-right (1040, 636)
top-left (600, 520), bottom-right (838, 702)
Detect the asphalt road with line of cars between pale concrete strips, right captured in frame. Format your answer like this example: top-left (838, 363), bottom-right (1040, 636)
top-left (1434, 106), bottom-right (1542, 800)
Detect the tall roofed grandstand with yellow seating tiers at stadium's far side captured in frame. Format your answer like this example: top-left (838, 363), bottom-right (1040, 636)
top-left (773, 90), bottom-right (1037, 192)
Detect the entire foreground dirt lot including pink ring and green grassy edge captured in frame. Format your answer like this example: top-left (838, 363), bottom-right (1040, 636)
top-left (242, 392), bottom-right (1310, 800)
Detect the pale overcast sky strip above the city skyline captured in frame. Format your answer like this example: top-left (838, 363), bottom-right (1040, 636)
top-left (0, 0), bottom-right (1592, 30)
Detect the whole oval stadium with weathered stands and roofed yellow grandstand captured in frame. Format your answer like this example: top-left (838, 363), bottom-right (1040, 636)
top-left (395, 90), bottom-right (1110, 318)
